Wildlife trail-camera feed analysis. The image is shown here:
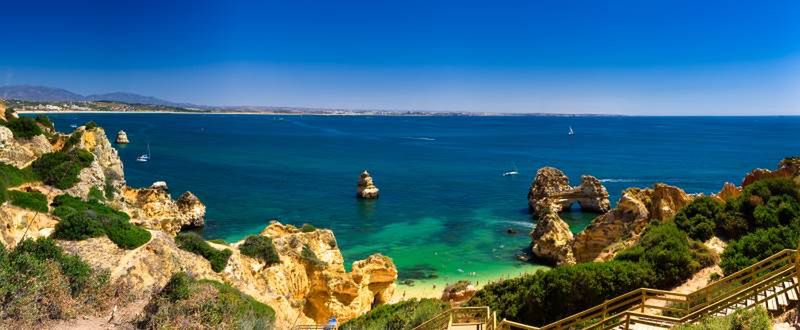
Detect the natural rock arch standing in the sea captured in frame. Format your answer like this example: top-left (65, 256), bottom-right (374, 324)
top-left (528, 167), bottom-right (611, 215)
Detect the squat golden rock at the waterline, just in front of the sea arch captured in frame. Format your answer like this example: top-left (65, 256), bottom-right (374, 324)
top-left (531, 212), bottom-right (575, 265)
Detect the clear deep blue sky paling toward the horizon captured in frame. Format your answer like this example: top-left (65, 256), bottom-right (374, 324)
top-left (0, 0), bottom-right (800, 114)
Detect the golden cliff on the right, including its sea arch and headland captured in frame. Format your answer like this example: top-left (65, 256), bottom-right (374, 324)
top-left (528, 167), bottom-right (693, 265)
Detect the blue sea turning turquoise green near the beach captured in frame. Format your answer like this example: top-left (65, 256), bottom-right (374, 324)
top-left (37, 114), bottom-right (800, 280)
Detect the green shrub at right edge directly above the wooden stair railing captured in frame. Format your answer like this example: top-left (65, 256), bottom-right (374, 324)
top-left (720, 226), bottom-right (800, 275)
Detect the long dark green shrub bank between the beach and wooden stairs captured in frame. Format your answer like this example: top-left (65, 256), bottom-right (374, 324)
top-left (467, 260), bottom-right (656, 326)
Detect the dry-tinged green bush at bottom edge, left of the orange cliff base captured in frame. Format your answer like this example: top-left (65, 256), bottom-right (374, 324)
top-left (137, 273), bottom-right (275, 329)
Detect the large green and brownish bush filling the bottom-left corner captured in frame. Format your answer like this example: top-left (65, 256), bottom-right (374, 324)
top-left (0, 238), bottom-right (113, 328)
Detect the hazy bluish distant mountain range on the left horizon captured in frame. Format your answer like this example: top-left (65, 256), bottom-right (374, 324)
top-left (0, 85), bottom-right (199, 108)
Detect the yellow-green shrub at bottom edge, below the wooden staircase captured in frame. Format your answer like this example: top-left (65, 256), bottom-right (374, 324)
top-left (674, 306), bottom-right (772, 330)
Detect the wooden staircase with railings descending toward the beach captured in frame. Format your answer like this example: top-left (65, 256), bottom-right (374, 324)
top-left (414, 249), bottom-right (800, 330)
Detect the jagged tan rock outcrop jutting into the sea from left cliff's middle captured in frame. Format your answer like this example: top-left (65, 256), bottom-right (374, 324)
top-left (121, 184), bottom-right (206, 235)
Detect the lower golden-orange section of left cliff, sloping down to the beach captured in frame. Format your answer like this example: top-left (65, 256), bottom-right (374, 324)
top-left (59, 223), bottom-right (397, 329)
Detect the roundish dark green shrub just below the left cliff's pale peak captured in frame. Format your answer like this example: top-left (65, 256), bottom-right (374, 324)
top-left (31, 149), bottom-right (94, 189)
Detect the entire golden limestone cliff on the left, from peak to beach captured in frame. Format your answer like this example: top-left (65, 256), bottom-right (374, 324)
top-left (0, 127), bottom-right (397, 329)
